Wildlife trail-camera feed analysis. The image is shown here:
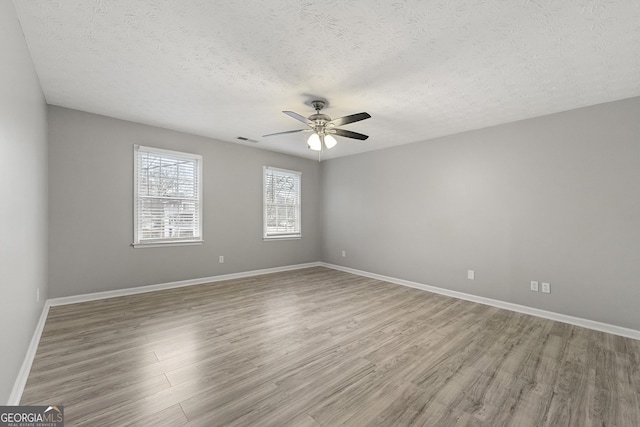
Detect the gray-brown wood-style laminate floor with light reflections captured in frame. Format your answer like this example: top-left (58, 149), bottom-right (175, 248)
top-left (21, 267), bottom-right (640, 427)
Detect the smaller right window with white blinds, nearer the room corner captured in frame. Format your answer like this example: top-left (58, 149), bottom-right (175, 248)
top-left (263, 166), bottom-right (302, 239)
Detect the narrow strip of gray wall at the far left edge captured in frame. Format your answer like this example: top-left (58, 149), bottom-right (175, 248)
top-left (0, 1), bottom-right (47, 404)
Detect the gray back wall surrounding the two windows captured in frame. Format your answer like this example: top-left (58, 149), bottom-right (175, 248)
top-left (48, 106), bottom-right (321, 297)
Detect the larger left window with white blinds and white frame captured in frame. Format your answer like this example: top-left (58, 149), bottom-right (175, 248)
top-left (133, 145), bottom-right (202, 247)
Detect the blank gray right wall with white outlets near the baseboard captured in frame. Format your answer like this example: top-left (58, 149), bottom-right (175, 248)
top-left (322, 98), bottom-right (640, 330)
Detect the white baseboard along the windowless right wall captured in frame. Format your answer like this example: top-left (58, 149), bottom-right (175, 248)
top-left (320, 262), bottom-right (640, 340)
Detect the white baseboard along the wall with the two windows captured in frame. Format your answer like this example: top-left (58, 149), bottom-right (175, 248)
top-left (48, 262), bottom-right (321, 307)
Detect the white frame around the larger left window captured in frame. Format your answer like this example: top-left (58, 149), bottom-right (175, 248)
top-left (131, 144), bottom-right (204, 248)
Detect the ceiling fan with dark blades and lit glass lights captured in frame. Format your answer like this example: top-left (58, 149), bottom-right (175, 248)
top-left (262, 100), bottom-right (371, 151)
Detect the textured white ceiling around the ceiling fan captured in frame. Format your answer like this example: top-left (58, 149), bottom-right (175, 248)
top-left (11, 0), bottom-right (640, 158)
